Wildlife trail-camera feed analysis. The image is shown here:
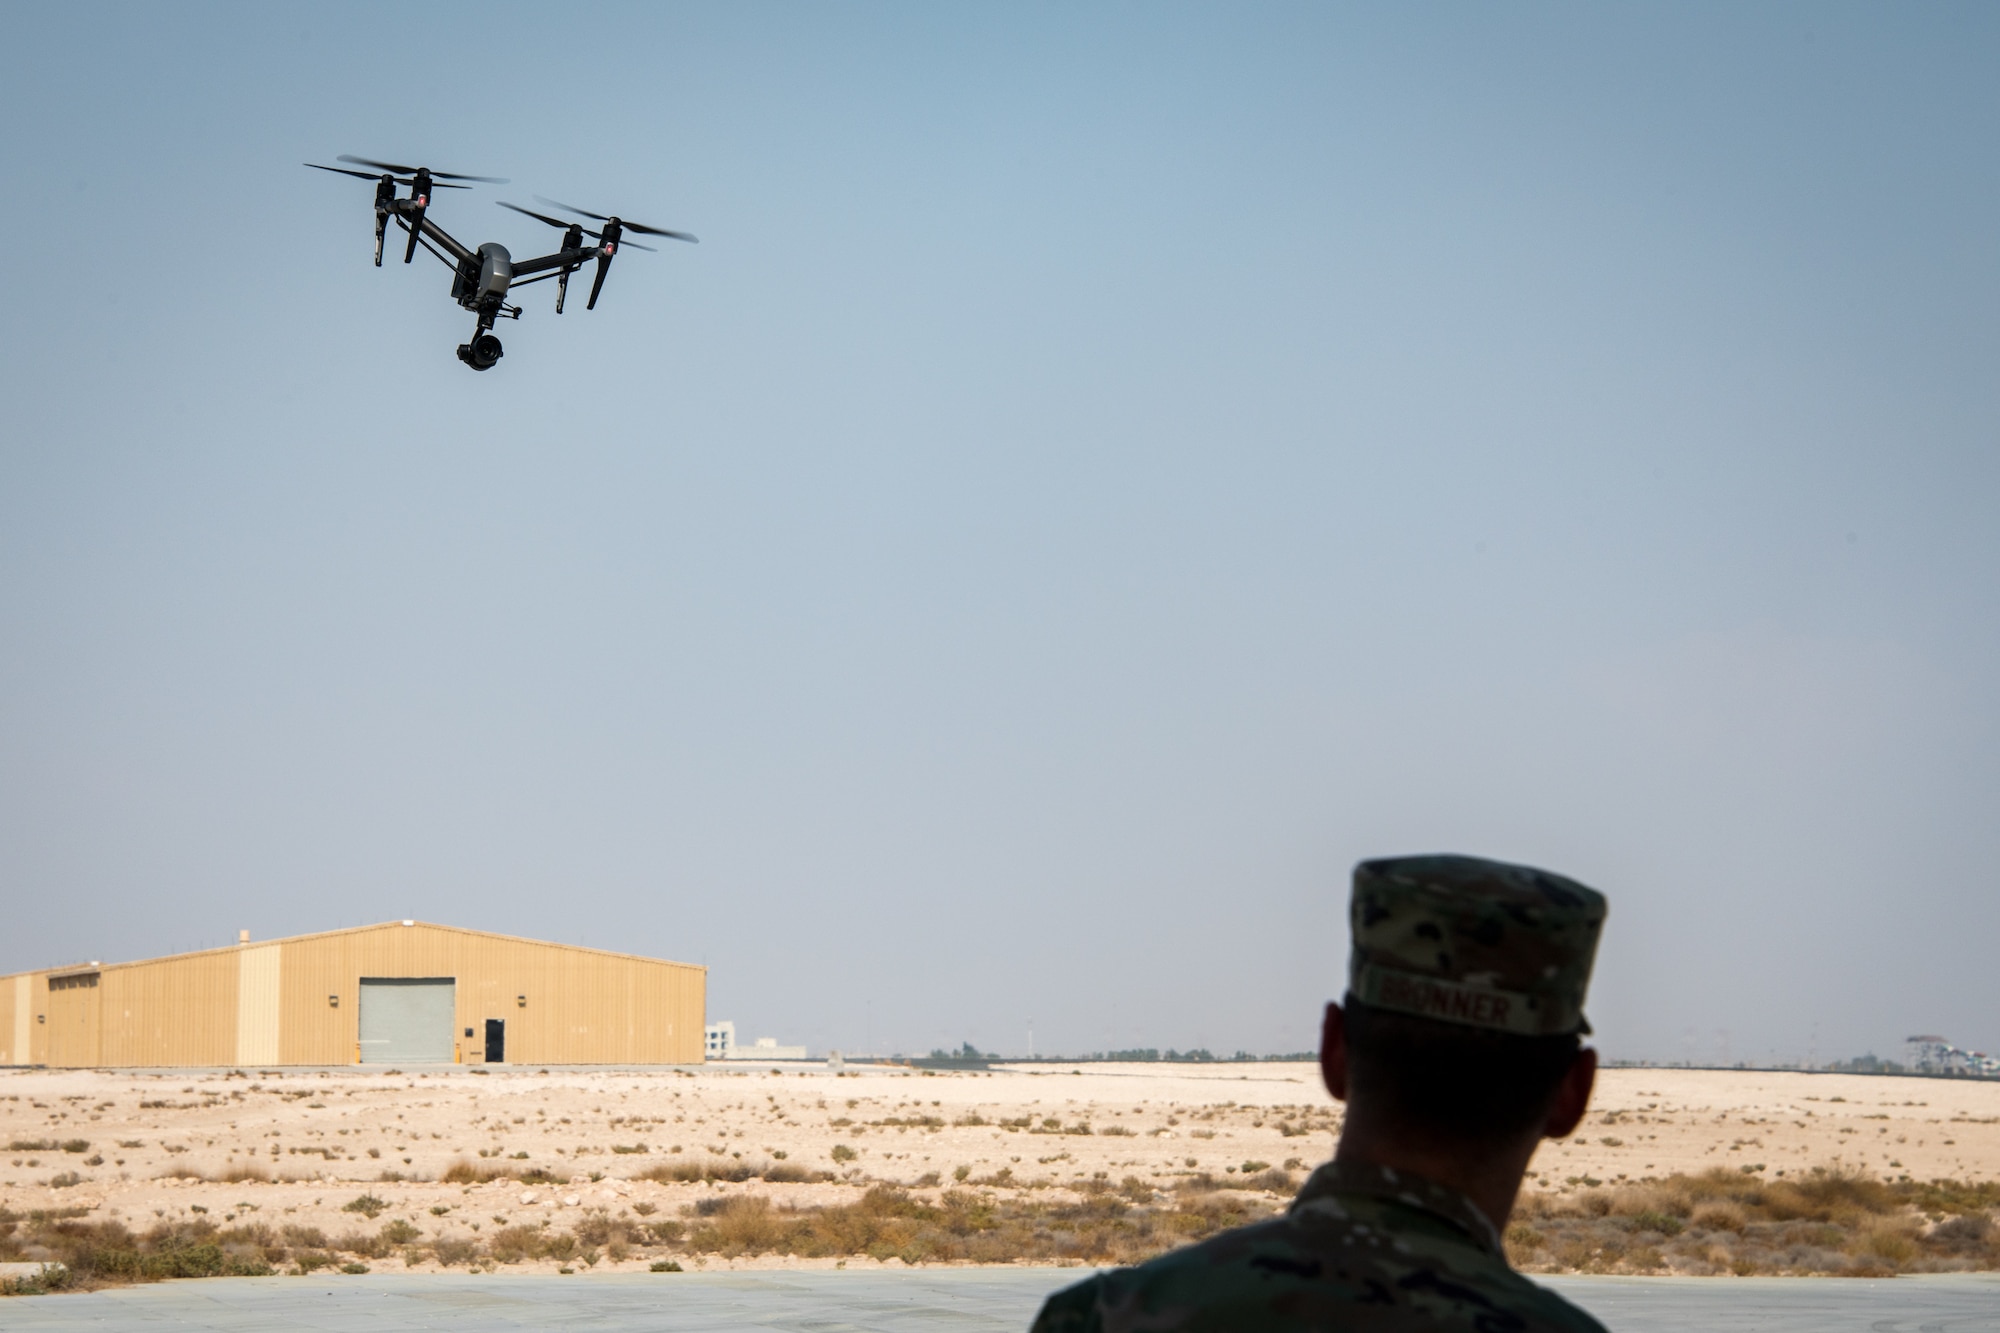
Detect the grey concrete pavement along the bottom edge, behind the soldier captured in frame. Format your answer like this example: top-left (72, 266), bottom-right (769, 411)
top-left (0, 1269), bottom-right (2000, 1333)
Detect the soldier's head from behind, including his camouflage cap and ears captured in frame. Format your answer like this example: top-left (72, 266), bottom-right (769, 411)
top-left (1328, 857), bottom-right (1604, 1149)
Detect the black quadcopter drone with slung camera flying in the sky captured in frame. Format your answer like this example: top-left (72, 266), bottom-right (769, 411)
top-left (306, 154), bottom-right (694, 370)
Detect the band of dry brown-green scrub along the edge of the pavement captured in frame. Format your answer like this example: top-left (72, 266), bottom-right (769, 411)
top-left (15, 1161), bottom-right (2000, 1291)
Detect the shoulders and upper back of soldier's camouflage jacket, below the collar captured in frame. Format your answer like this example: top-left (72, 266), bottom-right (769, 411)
top-left (1034, 1217), bottom-right (1604, 1333)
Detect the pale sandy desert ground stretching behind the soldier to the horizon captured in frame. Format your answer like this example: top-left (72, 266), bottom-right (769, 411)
top-left (0, 1063), bottom-right (2000, 1271)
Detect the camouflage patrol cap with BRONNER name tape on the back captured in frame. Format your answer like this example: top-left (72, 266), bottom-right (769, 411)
top-left (1348, 857), bottom-right (1604, 1037)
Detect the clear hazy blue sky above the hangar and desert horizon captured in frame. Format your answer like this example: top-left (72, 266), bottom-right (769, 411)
top-left (0, 4), bottom-right (2000, 1059)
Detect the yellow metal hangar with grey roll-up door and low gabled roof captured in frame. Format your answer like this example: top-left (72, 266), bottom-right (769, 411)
top-left (0, 921), bottom-right (708, 1069)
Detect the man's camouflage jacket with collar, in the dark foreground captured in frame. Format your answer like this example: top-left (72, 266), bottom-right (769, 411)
top-left (1034, 1163), bottom-right (1604, 1333)
